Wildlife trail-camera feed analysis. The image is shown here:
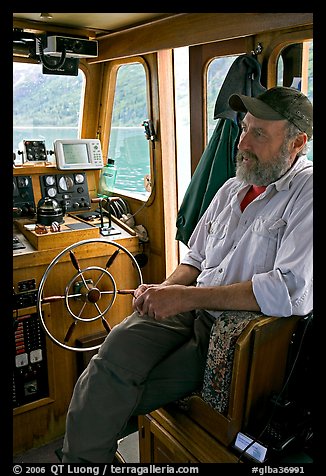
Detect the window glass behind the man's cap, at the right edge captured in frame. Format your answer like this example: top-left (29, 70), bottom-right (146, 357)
top-left (277, 40), bottom-right (313, 160)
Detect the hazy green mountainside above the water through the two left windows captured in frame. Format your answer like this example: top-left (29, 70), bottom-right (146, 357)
top-left (13, 63), bottom-right (148, 127)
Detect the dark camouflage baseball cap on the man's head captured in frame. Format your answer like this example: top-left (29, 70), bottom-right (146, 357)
top-left (229, 86), bottom-right (313, 139)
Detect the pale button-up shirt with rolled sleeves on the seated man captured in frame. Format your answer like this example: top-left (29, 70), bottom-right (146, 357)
top-left (181, 156), bottom-right (313, 317)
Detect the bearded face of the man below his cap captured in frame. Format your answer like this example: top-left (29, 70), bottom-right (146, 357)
top-left (236, 113), bottom-right (295, 186)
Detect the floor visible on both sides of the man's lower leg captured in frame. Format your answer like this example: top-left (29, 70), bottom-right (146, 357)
top-left (13, 431), bottom-right (139, 463)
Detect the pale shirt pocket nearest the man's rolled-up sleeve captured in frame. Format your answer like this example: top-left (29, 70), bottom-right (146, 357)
top-left (252, 217), bottom-right (286, 272)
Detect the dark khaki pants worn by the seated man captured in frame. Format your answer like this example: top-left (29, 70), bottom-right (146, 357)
top-left (63, 311), bottom-right (214, 463)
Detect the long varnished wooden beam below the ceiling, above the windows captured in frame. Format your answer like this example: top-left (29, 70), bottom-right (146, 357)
top-left (94, 13), bottom-right (313, 63)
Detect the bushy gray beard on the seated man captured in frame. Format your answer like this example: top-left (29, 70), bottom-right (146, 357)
top-left (236, 148), bottom-right (289, 186)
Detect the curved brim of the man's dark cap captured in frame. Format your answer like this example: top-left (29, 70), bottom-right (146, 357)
top-left (229, 94), bottom-right (285, 121)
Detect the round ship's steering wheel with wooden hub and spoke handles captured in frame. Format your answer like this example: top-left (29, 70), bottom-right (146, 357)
top-left (37, 239), bottom-right (143, 352)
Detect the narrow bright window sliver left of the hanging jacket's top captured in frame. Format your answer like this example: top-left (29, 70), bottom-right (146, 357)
top-left (206, 56), bottom-right (237, 142)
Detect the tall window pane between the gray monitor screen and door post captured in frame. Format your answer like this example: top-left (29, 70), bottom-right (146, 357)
top-left (108, 63), bottom-right (150, 198)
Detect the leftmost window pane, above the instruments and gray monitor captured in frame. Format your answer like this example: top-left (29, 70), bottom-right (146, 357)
top-left (13, 62), bottom-right (85, 163)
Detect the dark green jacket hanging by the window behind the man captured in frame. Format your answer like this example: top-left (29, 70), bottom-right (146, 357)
top-left (176, 54), bottom-right (266, 245)
